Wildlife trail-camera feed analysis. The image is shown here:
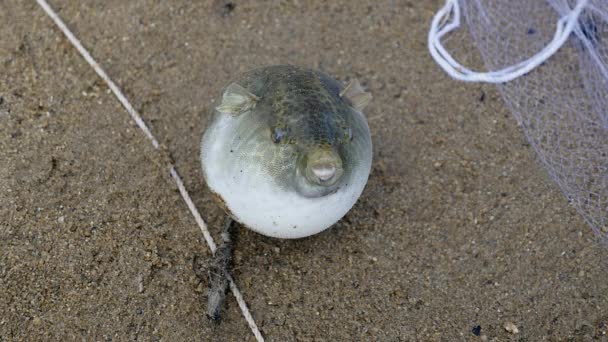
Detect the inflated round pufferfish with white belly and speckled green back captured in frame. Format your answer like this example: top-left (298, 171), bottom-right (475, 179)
top-left (201, 65), bottom-right (372, 238)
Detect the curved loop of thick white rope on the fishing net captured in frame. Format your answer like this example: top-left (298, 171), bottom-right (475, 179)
top-left (428, 0), bottom-right (589, 83)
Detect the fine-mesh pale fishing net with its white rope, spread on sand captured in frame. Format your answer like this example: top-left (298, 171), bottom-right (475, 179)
top-left (429, 0), bottom-right (608, 241)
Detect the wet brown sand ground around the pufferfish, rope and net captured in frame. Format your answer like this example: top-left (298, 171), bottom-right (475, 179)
top-left (0, 0), bottom-right (608, 342)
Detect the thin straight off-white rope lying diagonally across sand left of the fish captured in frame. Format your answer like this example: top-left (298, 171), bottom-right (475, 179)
top-left (36, 0), bottom-right (264, 341)
